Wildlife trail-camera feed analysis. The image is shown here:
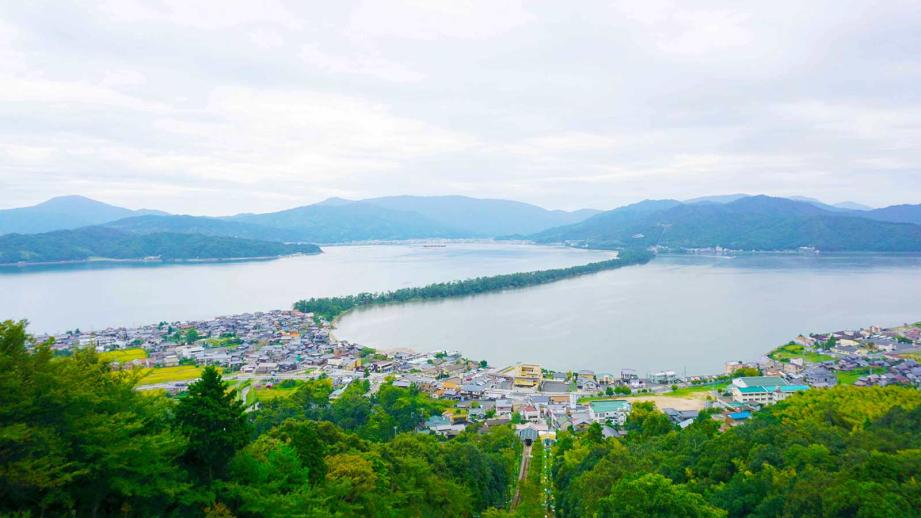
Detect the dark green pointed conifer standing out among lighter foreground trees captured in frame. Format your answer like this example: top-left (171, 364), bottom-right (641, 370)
top-left (176, 367), bottom-right (249, 482)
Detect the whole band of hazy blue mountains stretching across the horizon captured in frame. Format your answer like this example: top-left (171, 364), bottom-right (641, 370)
top-left (0, 194), bottom-right (921, 262)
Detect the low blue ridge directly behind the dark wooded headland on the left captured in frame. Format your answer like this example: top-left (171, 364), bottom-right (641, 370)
top-left (103, 216), bottom-right (310, 242)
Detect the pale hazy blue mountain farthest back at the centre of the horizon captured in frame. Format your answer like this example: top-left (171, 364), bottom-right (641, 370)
top-left (354, 196), bottom-right (601, 237)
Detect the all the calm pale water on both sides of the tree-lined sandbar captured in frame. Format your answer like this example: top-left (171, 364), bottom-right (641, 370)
top-left (7, 243), bottom-right (921, 373)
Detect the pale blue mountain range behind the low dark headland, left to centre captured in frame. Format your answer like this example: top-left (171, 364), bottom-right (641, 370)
top-left (0, 196), bottom-right (600, 243)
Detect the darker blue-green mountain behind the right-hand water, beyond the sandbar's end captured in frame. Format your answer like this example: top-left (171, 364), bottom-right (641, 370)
top-left (531, 196), bottom-right (921, 252)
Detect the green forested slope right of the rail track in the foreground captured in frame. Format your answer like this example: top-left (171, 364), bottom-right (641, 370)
top-left (553, 387), bottom-right (921, 517)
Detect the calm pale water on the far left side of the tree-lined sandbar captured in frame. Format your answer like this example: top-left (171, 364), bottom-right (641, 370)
top-left (0, 242), bottom-right (610, 333)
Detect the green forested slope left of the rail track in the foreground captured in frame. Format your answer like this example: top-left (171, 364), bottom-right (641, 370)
top-left (0, 321), bottom-right (521, 517)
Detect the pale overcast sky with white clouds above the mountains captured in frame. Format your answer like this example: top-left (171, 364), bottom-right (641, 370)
top-left (0, 0), bottom-right (921, 215)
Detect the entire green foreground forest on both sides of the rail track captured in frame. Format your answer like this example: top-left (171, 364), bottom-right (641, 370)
top-left (0, 321), bottom-right (921, 518)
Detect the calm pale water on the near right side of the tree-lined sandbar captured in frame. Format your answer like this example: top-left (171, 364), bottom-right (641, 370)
top-left (336, 255), bottom-right (921, 373)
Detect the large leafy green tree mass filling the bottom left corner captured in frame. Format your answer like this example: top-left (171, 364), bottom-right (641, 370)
top-left (0, 321), bottom-right (188, 516)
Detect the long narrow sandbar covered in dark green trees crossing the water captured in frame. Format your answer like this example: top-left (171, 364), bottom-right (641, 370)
top-left (294, 249), bottom-right (654, 321)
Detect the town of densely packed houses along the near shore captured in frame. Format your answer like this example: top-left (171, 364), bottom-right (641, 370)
top-left (34, 310), bottom-right (921, 443)
